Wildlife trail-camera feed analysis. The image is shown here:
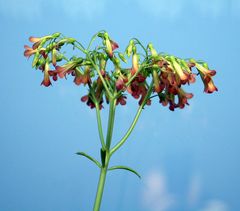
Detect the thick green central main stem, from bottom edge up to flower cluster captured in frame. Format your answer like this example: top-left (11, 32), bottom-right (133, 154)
top-left (93, 98), bottom-right (116, 211)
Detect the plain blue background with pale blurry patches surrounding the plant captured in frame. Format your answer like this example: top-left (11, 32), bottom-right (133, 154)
top-left (0, 0), bottom-right (240, 211)
